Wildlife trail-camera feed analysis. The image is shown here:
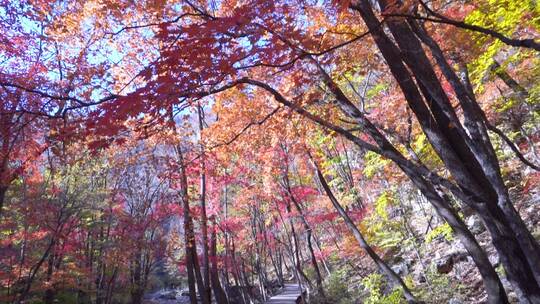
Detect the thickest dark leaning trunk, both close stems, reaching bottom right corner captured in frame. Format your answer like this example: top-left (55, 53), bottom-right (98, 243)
top-left (348, 0), bottom-right (538, 301)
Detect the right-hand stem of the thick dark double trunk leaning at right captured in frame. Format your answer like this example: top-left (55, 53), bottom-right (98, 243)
top-left (379, 1), bottom-right (540, 283)
